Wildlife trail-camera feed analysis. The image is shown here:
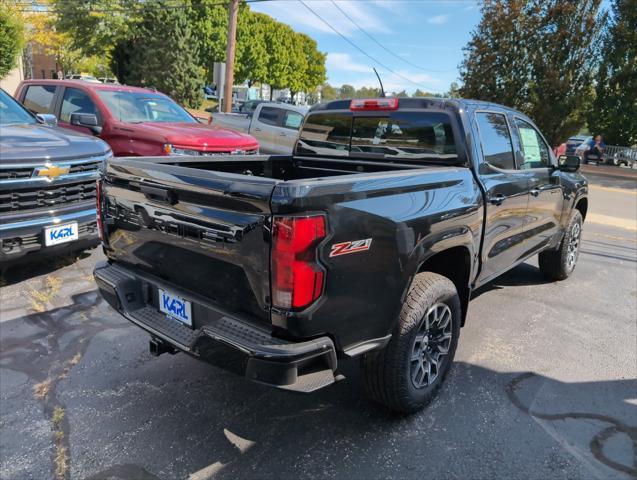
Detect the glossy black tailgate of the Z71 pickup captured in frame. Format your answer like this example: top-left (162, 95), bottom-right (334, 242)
top-left (102, 158), bottom-right (277, 323)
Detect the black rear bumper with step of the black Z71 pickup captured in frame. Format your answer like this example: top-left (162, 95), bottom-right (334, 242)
top-left (93, 263), bottom-right (339, 392)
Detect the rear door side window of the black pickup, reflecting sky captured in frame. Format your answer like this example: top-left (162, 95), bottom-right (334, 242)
top-left (476, 112), bottom-right (515, 170)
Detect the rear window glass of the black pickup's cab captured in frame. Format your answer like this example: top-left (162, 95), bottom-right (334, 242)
top-left (297, 111), bottom-right (457, 160)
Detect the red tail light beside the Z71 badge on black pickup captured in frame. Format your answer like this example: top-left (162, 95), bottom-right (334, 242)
top-left (272, 215), bottom-right (326, 309)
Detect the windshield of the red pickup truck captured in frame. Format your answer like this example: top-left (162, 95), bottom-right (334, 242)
top-left (97, 90), bottom-right (197, 123)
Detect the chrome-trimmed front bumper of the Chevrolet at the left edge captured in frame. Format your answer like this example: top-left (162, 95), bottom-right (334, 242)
top-left (0, 208), bottom-right (99, 266)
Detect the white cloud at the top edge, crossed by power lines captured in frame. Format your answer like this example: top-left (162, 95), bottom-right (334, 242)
top-left (250, 0), bottom-right (389, 36)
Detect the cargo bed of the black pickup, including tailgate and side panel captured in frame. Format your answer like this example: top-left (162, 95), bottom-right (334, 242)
top-left (102, 156), bottom-right (480, 348)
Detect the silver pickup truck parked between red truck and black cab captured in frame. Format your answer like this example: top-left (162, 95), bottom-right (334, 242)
top-left (212, 103), bottom-right (307, 155)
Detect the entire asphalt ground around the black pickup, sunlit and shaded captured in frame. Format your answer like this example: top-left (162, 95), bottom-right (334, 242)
top-left (0, 171), bottom-right (637, 480)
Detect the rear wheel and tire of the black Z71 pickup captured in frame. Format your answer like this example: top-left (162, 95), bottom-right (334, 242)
top-left (361, 272), bottom-right (461, 413)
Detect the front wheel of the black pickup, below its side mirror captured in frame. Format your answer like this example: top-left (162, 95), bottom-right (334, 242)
top-left (538, 210), bottom-right (583, 280)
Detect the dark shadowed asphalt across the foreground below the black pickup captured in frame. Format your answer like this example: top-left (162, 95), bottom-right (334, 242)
top-left (0, 292), bottom-right (637, 480)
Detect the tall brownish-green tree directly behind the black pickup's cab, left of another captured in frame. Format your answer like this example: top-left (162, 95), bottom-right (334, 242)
top-left (460, 0), bottom-right (605, 145)
